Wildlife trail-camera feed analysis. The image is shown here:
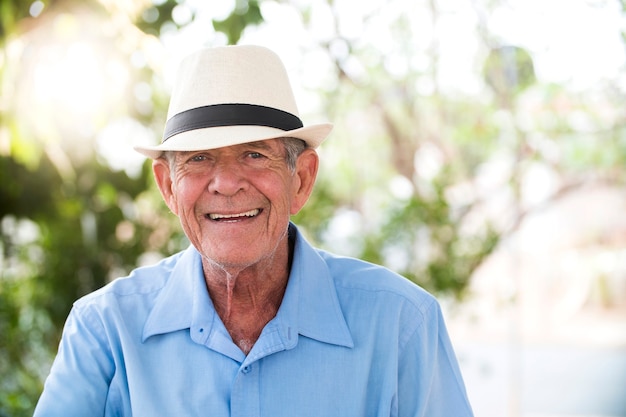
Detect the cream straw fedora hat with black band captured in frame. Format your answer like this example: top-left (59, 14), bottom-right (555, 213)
top-left (135, 45), bottom-right (333, 159)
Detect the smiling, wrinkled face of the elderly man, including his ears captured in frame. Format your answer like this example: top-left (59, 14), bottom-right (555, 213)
top-left (153, 139), bottom-right (318, 268)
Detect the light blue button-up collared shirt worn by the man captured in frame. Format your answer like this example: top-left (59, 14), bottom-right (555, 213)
top-left (35, 225), bottom-right (472, 417)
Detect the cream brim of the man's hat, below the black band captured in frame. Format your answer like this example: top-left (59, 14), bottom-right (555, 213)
top-left (134, 123), bottom-right (333, 159)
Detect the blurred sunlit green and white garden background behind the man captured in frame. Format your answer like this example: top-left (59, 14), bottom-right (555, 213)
top-left (0, 0), bottom-right (626, 417)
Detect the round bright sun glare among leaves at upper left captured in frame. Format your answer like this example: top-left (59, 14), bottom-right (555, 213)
top-left (7, 10), bottom-right (132, 162)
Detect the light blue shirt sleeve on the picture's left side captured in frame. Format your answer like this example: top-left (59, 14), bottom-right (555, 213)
top-left (34, 306), bottom-right (115, 417)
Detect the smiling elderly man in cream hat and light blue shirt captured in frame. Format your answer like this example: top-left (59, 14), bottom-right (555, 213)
top-left (35, 46), bottom-right (472, 417)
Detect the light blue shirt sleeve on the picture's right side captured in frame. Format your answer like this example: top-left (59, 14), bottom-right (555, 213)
top-left (397, 300), bottom-right (473, 417)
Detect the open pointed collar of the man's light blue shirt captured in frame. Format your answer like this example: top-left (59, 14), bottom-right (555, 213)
top-left (142, 224), bottom-right (354, 349)
